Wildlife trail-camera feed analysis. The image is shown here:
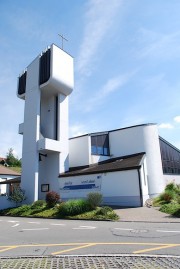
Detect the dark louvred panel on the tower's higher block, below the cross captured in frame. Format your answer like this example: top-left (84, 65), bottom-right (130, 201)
top-left (39, 49), bottom-right (51, 85)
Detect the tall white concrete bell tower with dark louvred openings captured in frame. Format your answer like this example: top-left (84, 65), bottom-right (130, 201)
top-left (17, 44), bottom-right (74, 203)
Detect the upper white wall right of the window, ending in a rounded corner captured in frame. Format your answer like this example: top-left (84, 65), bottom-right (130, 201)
top-left (109, 124), bottom-right (164, 197)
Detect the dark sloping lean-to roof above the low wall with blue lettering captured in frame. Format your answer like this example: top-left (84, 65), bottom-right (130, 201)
top-left (59, 152), bottom-right (145, 177)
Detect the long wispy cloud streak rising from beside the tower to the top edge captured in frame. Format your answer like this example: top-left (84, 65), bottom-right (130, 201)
top-left (77, 0), bottom-right (122, 75)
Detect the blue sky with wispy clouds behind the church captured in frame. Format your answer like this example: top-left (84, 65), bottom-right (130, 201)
top-left (0, 0), bottom-right (180, 158)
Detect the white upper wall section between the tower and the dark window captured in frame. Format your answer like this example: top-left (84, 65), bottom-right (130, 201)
top-left (69, 135), bottom-right (91, 167)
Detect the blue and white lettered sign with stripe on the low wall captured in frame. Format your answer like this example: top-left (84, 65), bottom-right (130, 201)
top-left (59, 176), bottom-right (102, 192)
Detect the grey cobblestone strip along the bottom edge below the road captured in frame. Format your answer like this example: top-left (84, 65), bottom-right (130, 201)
top-left (0, 255), bottom-right (180, 269)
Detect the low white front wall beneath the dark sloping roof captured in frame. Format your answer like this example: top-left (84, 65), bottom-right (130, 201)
top-left (59, 170), bottom-right (141, 207)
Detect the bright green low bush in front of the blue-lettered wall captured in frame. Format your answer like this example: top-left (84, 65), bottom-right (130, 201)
top-left (59, 199), bottom-right (90, 216)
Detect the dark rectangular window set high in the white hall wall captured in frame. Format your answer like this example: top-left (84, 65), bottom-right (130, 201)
top-left (91, 134), bottom-right (109, 156)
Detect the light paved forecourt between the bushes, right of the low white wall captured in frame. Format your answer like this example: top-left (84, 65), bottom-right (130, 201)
top-left (114, 207), bottom-right (180, 223)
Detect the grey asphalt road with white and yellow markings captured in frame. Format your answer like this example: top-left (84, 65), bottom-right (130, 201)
top-left (0, 217), bottom-right (180, 257)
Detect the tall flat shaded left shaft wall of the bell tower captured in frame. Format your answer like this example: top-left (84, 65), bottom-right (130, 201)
top-left (21, 57), bottom-right (41, 202)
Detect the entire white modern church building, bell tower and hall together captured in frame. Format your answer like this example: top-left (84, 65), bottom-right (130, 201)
top-left (17, 44), bottom-right (180, 207)
